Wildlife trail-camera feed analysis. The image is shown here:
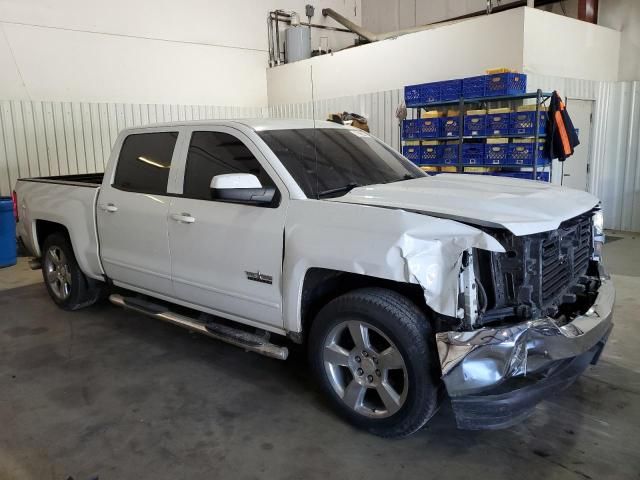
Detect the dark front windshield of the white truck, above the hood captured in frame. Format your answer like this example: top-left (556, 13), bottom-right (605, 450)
top-left (258, 128), bottom-right (426, 198)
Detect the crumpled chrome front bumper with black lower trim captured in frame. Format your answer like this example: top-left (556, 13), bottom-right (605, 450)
top-left (436, 277), bottom-right (615, 430)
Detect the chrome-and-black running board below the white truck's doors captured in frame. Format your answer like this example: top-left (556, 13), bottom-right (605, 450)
top-left (109, 294), bottom-right (289, 360)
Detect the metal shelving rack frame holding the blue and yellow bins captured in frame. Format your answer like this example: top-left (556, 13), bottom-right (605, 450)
top-left (403, 89), bottom-right (552, 182)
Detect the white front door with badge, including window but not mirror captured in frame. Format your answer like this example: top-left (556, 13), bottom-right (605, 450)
top-left (169, 127), bottom-right (288, 328)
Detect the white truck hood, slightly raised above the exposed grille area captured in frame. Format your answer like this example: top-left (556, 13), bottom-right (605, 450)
top-left (331, 173), bottom-right (599, 236)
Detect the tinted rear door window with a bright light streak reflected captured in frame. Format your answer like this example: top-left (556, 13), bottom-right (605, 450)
top-left (113, 132), bottom-right (178, 194)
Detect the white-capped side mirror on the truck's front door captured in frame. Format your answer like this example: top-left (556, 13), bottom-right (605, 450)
top-left (210, 173), bottom-right (276, 206)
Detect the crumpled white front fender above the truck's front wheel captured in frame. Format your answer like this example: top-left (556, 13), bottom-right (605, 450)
top-left (283, 200), bottom-right (504, 331)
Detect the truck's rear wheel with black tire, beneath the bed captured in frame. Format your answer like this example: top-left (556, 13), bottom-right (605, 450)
top-left (42, 233), bottom-right (105, 310)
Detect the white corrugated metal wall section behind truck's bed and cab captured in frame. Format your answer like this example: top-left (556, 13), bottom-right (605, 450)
top-left (0, 100), bottom-right (267, 195)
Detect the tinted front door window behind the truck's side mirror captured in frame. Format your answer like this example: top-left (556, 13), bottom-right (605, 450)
top-left (182, 131), bottom-right (275, 200)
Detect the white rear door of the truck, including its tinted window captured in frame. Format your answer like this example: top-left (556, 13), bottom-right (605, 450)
top-left (96, 128), bottom-right (179, 296)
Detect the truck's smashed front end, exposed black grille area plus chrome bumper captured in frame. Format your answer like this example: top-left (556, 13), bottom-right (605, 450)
top-left (436, 212), bottom-right (615, 429)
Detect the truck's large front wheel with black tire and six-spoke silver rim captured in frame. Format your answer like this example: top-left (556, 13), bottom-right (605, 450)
top-left (309, 288), bottom-right (440, 438)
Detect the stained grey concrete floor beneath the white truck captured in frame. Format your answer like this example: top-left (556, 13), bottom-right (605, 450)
top-left (0, 232), bottom-right (640, 480)
